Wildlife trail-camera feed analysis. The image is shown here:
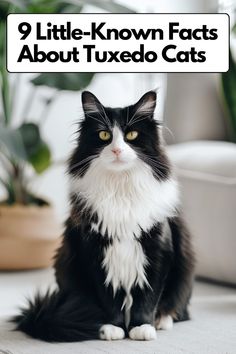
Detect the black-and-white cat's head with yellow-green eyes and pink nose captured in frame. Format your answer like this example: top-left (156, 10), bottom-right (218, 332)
top-left (69, 91), bottom-right (169, 179)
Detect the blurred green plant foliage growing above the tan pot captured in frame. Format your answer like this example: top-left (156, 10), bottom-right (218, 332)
top-left (0, 0), bottom-right (134, 205)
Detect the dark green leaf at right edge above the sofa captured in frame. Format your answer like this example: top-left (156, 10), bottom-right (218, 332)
top-left (222, 48), bottom-right (236, 142)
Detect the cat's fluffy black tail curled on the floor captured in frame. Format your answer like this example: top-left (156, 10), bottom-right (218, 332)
top-left (12, 291), bottom-right (104, 342)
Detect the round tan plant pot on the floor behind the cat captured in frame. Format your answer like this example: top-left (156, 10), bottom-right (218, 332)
top-left (0, 205), bottom-right (62, 270)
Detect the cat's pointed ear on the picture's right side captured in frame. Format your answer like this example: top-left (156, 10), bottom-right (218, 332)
top-left (134, 91), bottom-right (157, 118)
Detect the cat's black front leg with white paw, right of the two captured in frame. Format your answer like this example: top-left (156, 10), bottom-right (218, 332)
top-left (128, 288), bottom-right (157, 340)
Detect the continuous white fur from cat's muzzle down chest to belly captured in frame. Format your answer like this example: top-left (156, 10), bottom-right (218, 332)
top-left (72, 127), bottom-right (178, 323)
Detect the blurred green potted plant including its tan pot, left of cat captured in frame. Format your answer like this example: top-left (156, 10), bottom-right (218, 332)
top-left (0, 0), bottom-right (132, 270)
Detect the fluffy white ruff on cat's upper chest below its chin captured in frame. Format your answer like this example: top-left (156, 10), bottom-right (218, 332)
top-left (72, 160), bottom-right (178, 240)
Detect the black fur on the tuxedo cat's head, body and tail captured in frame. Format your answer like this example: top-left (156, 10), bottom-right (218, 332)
top-left (14, 92), bottom-right (194, 342)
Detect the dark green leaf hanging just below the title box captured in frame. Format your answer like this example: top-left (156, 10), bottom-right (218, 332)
top-left (32, 73), bottom-right (94, 91)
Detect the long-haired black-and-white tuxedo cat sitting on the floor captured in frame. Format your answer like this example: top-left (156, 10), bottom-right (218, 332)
top-left (14, 91), bottom-right (194, 342)
